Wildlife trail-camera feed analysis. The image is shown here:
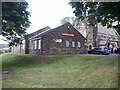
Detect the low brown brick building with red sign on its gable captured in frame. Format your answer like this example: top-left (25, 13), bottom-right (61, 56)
top-left (12, 23), bottom-right (86, 55)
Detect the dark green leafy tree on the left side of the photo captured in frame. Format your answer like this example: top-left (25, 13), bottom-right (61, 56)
top-left (2, 2), bottom-right (30, 46)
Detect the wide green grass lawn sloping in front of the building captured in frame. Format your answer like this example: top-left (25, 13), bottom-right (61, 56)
top-left (0, 53), bottom-right (118, 88)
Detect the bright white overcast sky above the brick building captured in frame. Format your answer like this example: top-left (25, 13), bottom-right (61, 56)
top-left (26, 0), bottom-right (74, 33)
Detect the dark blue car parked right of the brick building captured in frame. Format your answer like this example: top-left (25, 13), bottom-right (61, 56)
top-left (88, 48), bottom-right (110, 55)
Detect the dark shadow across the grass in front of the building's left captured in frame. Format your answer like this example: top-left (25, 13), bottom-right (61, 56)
top-left (2, 54), bottom-right (71, 71)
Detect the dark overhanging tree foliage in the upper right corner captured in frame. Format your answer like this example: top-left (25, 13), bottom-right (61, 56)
top-left (70, 0), bottom-right (120, 34)
